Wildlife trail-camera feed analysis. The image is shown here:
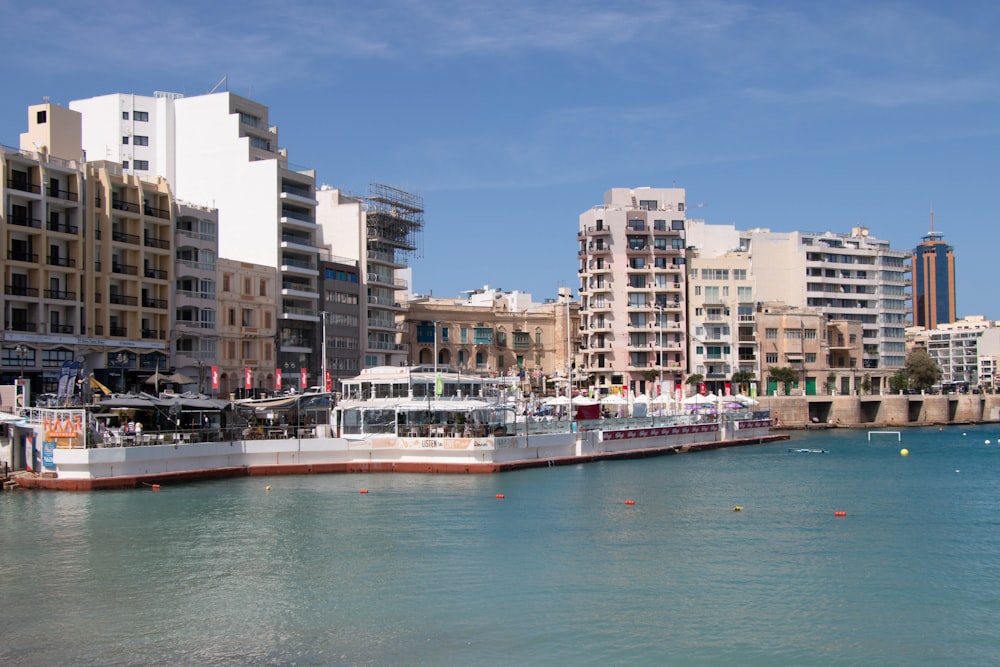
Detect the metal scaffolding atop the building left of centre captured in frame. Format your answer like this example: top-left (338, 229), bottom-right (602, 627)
top-left (365, 183), bottom-right (424, 255)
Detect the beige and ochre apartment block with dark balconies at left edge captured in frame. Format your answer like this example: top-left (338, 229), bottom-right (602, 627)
top-left (2, 103), bottom-right (173, 393)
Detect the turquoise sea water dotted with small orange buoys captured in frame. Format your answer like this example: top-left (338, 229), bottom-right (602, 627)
top-left (0, 426), bottom-right (1000, 666)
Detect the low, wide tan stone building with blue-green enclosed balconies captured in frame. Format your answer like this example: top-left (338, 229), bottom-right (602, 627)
top-left (402, 288), bottom-right (590, 394)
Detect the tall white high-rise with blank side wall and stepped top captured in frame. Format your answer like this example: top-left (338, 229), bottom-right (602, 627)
top-left (70, 92), bottom-right (321, 384)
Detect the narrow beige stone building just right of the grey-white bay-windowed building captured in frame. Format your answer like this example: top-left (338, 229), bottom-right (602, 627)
top-left (213, 258), bottom-right (278, 398)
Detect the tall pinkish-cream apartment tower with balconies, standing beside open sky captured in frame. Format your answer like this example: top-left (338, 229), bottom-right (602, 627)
top-left (577, 188), bottom-right (687, 394)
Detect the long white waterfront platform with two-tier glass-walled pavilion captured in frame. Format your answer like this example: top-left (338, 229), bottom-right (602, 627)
top-left (11, 366), bottom-right (788, 490)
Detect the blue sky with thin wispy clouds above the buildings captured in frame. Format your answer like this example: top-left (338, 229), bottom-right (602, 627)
top-left (0, 0), bottom-right (1000, 319)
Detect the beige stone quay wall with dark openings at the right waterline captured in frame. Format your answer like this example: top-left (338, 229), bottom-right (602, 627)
top-left (758, 394), bottom-right (1000, 428)
